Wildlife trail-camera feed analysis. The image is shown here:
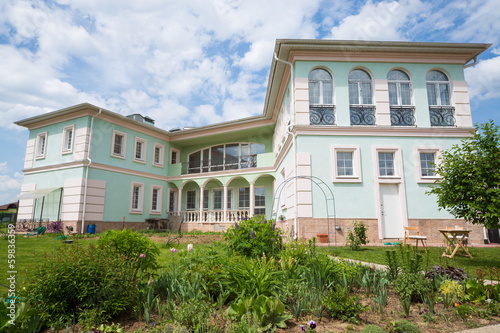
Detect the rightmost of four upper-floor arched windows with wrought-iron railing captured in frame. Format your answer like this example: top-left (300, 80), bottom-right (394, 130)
top-left (426, 70), bottom-right (455, 126)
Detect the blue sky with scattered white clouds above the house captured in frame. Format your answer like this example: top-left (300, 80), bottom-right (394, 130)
top-left (0, 0), bottom-right (500, 204)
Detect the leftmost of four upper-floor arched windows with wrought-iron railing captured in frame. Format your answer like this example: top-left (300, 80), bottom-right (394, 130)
top-left (309, 68), bottom-right (335, 125)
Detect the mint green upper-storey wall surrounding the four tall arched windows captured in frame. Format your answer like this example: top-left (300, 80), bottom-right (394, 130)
top-left (295, 61), bottom-right (464, 127)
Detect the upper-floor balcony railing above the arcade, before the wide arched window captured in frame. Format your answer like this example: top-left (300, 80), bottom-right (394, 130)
top-left (181, 154), bottom-right (257, 175)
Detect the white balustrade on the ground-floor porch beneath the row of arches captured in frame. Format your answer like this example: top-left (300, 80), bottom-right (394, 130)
top-left (170, 209), bottom-right (250, 223)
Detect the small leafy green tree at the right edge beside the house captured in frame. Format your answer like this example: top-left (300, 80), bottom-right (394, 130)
top-left (427, 120), bottom-right (500, 229)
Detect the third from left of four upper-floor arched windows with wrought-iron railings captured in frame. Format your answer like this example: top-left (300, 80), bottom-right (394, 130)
top-left (387, 69), bottom-right (415, 126)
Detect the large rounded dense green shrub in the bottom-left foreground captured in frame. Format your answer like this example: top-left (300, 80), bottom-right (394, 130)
top-left (23, 245), bottom-right (137, 326)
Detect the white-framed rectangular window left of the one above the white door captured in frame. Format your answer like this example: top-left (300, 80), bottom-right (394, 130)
top-left (332, 146), bottom-right (361, 183)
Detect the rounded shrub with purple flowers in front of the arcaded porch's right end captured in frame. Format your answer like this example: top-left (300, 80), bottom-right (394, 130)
top-left (224, 216), bottom-right (283, 258)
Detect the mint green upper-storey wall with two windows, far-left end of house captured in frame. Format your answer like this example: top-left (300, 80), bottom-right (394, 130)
top-left (29, 117), bottom-right (89, 168)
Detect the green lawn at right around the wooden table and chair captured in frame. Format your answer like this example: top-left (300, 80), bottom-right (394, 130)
top-left (318, 246), bottom-right (500, 275)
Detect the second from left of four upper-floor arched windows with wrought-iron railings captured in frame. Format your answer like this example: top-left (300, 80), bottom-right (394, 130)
top-left (349, 69), bottom-right (375, 125)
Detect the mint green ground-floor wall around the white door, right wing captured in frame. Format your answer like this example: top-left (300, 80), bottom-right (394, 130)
top-left (297, 136), bottom-right (459, 219)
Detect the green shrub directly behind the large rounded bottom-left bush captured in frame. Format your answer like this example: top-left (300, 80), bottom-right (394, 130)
top-left (98, 229), bottom-right (160, 279)
